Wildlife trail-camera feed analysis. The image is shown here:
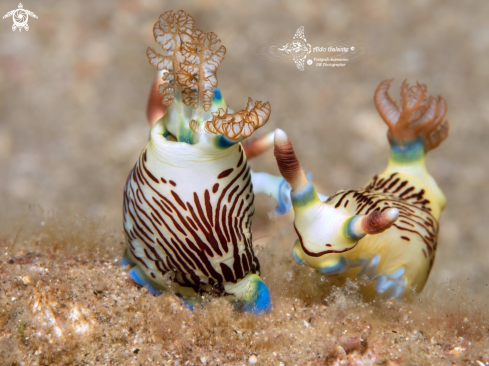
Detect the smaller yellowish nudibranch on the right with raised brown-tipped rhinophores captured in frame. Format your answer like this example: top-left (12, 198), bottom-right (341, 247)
top-left (275, 80), bottom-right (449, 298)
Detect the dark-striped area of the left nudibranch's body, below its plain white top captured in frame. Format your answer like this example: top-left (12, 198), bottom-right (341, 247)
top-left (123, 149), bottom-right (260, 294)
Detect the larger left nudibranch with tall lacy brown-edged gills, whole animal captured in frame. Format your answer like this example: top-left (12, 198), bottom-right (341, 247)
top-left (123, 10), bottom-right (291, 313)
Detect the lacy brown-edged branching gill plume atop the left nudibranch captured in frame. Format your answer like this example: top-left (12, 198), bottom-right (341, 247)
top-left (147, 10), bottom-right (271, 143)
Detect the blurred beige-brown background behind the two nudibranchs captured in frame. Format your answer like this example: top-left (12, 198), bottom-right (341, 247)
top-left (0, 0), bottom-right (489, 290)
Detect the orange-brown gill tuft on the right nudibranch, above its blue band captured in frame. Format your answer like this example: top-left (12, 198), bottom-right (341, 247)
top-left (374, 79), bottom-right (449, 151)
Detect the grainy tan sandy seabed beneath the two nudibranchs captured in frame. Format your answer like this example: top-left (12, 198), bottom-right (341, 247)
top-left (0, 212), bottom-right (489, 366)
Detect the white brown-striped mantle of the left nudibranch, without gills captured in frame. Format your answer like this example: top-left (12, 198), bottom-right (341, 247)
top-left (124, 121), bottom-right (260, 298)
